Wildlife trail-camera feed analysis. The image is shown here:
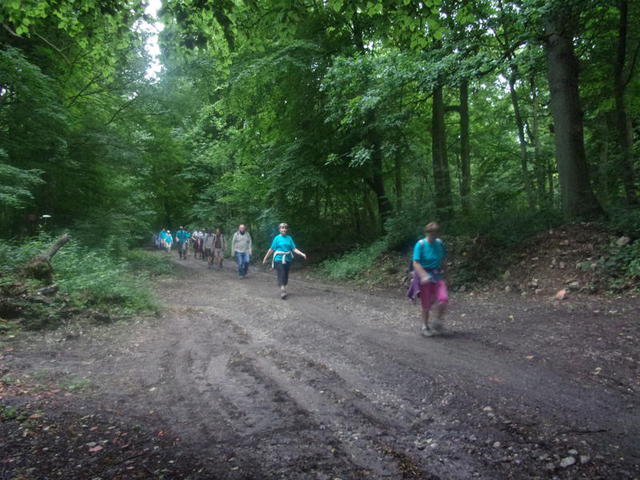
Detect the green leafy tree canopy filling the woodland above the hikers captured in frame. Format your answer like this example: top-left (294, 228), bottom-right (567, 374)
top-left (0, 0), bottom-right (640, 288)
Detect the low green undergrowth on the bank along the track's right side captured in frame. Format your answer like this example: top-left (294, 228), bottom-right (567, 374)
top-left (320, 204), bottom-right (640, 290)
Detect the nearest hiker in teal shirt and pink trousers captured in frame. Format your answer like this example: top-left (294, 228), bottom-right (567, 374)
top-left (413, 222), bottom-right (449, 337)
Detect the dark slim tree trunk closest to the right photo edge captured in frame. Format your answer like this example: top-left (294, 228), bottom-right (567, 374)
top-left (614, 0), bottom-right (638, 205)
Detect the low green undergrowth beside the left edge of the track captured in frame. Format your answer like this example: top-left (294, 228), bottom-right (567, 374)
top-left (0, 235), bottom-right (173, 335)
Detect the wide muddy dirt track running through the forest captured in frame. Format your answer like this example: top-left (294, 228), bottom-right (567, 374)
top-left (5, 258), bottom-right (640, 480)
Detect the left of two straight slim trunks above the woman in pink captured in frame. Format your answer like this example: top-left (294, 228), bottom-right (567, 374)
top-left (431, 86), bottom-right (453, 219)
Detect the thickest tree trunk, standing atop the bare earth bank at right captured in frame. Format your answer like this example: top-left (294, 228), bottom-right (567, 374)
top-left (545, 8), bottom-right (602, 218)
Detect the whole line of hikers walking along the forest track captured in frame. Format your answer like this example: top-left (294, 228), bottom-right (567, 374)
top-left (154, 222), bottom-right (449, 337)
